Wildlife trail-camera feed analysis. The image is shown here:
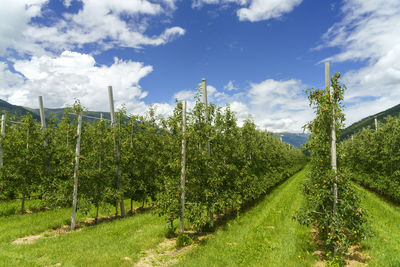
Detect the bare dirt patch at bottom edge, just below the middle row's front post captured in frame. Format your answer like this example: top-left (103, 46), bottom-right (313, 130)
top-left (134, 234), bottom-right (212, 267)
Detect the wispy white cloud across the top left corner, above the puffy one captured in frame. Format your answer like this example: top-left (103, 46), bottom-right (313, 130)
top-left (0, 0), bottom-right (185, 55)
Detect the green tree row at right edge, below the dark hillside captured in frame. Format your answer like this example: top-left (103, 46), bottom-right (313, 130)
top-left (341, 117), bottom-right (400, 202)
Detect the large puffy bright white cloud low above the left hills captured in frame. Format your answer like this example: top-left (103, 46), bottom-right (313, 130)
top-left (0, 51), bottom-right (157, 113)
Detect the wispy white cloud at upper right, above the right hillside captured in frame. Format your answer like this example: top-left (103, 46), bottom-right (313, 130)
top-left (318, 0), bottom-right (400, 126)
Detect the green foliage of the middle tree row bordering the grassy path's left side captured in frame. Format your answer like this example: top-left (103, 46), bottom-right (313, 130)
top-left (158, 87), bottom-right (305, 231)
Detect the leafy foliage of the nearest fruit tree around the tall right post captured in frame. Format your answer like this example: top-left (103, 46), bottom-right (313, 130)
top-left (298, 74), bottom-right (366, 259)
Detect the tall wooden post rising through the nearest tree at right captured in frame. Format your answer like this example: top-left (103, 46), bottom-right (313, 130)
top-left (325, 62), bottom-right (338, 212)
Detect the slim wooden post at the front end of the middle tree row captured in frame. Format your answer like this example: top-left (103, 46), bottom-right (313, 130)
top-left (179, 101), bottom-right (186, 233)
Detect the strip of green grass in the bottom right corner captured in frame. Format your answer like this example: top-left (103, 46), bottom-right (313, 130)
top-left (357, 186), bottom-right (400, 266)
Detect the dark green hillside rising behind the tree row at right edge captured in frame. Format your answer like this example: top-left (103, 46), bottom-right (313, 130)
top-left (340, 104), bottom-right (400, 140)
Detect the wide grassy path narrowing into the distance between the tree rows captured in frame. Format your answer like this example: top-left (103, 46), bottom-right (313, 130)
top-left (173, 169), bottom-right (317, 266)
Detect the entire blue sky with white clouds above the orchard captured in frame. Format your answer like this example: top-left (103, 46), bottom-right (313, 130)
top-left (0, 0), bottom-right (400, 132)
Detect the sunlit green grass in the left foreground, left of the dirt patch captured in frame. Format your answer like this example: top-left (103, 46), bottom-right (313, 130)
top-left (0, 201), bottom-right (165, 266)
